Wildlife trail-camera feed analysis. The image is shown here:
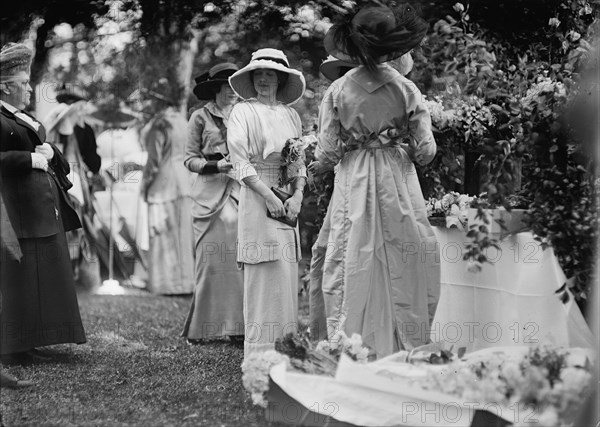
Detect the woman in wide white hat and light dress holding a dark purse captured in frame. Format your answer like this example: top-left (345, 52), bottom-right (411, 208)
top-left (227, 49), bottom-right (306, 356)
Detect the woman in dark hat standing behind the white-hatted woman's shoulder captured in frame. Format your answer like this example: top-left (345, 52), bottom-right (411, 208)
top-left (182, 63), bottom-right (244, 342)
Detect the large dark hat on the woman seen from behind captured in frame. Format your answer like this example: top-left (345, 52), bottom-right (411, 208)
top-left (324, 4), bottom-right (427, 70)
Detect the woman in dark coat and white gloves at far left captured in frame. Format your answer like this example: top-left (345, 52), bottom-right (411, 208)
top-left (0, 43), bottom-right (86, 358)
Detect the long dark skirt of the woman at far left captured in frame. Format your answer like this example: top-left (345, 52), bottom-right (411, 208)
top-left (0, 181), bottom-right (86, 354)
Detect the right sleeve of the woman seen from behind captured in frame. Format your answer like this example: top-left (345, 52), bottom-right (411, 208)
top-left (405, 81), bottom-right (437, 165)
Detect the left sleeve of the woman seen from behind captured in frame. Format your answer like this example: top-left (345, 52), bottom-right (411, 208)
top-left (315, 85), bottom-right (343, 169)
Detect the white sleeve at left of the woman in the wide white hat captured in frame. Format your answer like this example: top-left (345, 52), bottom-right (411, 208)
top-left (227, 103), bottom-right (258, 182)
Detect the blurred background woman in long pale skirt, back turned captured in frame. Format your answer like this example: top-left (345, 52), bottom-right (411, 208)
top-left (140, 90), bottom-right (194, 295)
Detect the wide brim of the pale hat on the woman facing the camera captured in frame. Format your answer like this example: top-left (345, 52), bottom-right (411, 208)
top-left (229, 59), bottom-right (306, 105)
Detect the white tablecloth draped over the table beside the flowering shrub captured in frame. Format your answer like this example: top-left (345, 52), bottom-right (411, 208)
top-left (431, 227), bottom-right (595, 352)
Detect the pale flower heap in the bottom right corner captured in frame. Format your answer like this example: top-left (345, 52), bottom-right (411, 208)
top-left (398, 346), bottom-right (593, 427)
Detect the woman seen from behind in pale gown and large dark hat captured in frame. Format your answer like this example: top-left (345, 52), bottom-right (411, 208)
top-left (315, 6), bottom-right (440, 357)
